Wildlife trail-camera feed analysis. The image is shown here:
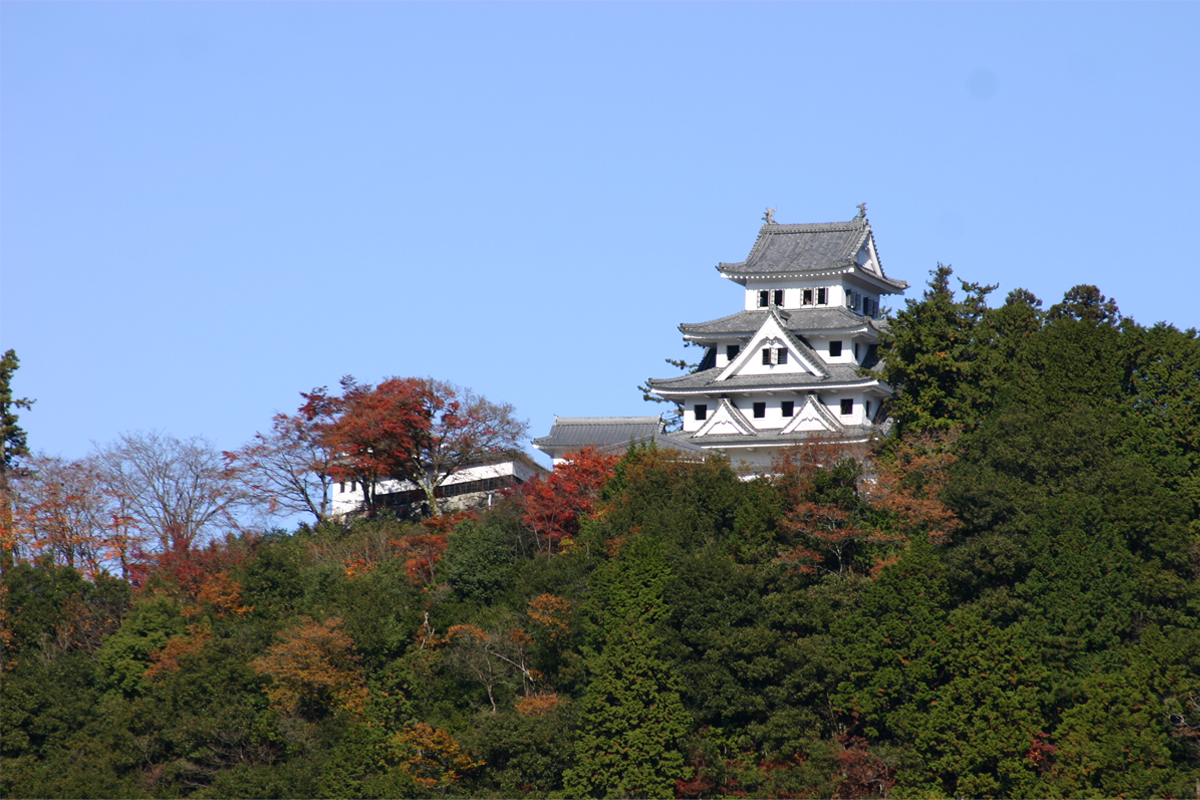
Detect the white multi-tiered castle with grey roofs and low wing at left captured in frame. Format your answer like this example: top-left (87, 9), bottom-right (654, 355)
top-left (533, 204), bottom-right (908, 467)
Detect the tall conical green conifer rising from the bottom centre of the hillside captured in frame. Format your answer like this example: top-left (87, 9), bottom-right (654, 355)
top-left (564, 534), bottom-right (691, 798)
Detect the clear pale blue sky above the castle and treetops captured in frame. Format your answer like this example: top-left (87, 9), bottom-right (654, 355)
top-left (0, 1), bottom-right (1200, 457)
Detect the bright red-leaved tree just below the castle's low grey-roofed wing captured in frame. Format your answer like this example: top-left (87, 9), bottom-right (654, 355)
top-left (521, 447), bottom-right (619, 553)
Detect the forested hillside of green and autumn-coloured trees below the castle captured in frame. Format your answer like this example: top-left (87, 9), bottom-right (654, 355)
top-left (0, 267), bottom-right (1200, 798)
